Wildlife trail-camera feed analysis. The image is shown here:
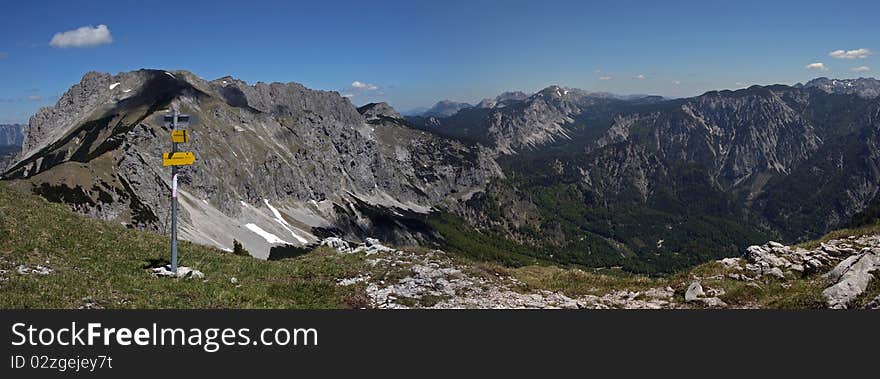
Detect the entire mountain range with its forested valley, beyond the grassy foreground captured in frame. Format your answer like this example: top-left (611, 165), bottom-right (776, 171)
top-left (3, 70), bottom-right (880, 273)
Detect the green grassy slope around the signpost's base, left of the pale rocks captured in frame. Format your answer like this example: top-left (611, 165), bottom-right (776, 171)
top-left (0, 184), bottom-right (365, 308)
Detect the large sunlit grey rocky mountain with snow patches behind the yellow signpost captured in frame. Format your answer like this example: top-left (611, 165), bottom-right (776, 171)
top-left (4, 70), bottom-right (500, 258)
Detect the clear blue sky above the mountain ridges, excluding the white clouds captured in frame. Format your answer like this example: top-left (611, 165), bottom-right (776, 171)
top-left (0, 0), bottom-right (880, 123)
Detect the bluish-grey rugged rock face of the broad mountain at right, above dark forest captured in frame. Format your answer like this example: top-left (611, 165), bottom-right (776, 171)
top-left (596, 89), bottom-right (822, 190)
